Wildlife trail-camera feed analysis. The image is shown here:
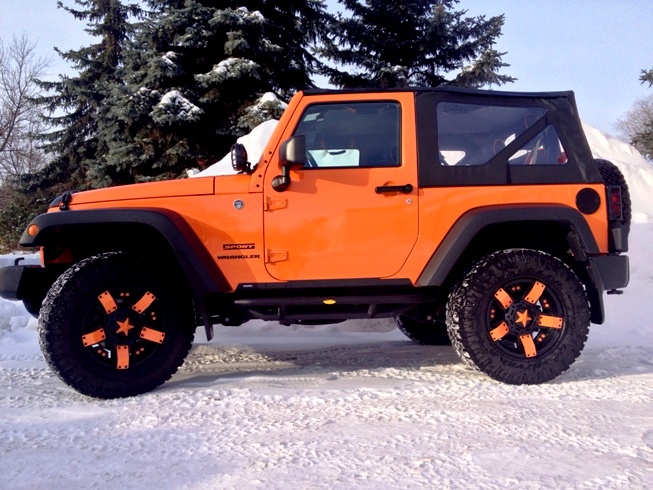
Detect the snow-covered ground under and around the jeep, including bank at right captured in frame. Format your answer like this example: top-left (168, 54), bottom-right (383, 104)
top-left (0, 127), bottom-right (653, 490)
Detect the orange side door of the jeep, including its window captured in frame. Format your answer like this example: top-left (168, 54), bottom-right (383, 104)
top-left (264, 92), bottom-right (418, 281)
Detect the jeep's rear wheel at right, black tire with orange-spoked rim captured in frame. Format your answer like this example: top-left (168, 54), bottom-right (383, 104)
top-left (447, 249), bottom-right (590, 384)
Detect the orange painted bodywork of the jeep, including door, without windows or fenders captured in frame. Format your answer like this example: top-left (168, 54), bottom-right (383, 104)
top-left (53, 92), bottom-right (608, 289)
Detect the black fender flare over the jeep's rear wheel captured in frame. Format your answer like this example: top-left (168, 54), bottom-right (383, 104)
top-left (417, 205), bottom-right (605, 323)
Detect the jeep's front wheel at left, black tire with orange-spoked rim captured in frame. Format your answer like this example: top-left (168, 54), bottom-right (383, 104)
top-left (39, 253), bottom-right (195, 398)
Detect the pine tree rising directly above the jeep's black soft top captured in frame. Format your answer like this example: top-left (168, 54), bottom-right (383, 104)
top-left (318, 0), bottom-right (514, 88)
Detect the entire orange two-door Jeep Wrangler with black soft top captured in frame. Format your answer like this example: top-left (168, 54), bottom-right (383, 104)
top-left (0, 88), bottom-right (630, 398)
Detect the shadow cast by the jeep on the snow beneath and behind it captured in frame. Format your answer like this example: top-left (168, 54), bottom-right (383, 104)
top-left (165, 340), bottom-right (653, 388)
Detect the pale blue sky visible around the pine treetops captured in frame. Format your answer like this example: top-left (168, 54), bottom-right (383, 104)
top-left (0, 0), bottom-right (653, 133)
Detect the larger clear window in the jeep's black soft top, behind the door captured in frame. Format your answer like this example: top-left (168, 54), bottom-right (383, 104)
top-left (437, 102), bottom-right (544, 166)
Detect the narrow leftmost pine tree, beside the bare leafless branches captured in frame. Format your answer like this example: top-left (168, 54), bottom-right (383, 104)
top-left (24, 0), bottom-right (140, 191)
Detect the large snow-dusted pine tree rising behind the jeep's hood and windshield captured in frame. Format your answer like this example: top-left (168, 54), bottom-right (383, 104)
top-left (94, 0), bottom-right (325, 183)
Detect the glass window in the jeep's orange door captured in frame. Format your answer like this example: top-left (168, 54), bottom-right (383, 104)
top-left (294, 102), bottom-right (401, 168)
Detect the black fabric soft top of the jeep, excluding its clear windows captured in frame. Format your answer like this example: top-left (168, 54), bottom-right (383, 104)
top-left (304, 85), bottom-right (602, 187)
